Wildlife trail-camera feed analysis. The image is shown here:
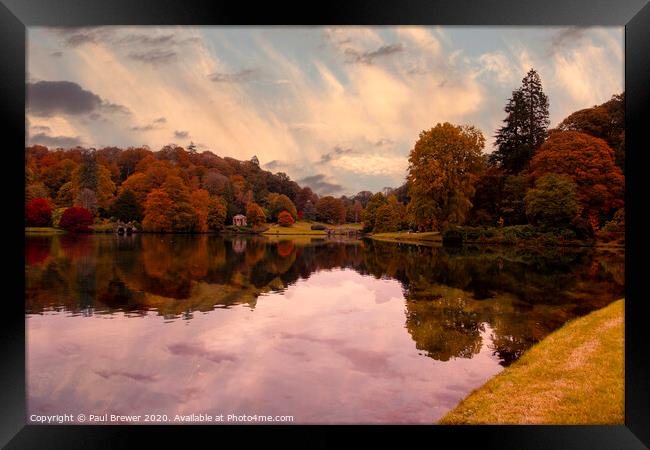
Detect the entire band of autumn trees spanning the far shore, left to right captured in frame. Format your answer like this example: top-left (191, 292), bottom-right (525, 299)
top-left (25, 69), bottom-right (625, 239)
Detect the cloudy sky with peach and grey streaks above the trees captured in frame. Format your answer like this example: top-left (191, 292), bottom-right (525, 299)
top-left (26, 26), bottom-right (624, 196)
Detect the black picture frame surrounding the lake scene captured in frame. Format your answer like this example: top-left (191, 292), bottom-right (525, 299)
top-left (0, 0), bottom-right (650, 449)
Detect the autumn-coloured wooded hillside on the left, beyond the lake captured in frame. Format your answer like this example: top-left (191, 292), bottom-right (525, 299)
top-left (25, 145), bottom-right (371, 232)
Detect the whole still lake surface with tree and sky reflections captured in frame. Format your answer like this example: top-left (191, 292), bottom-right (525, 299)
top-left (25, 235), bottom-right (624, 424)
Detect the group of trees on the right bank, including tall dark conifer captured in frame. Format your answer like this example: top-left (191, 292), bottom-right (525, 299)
top-left (363, 69), bottom-right (625, 238)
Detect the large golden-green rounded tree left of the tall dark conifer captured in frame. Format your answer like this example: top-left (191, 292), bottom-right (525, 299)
top-left (407, 123), bottom-right (485, 231)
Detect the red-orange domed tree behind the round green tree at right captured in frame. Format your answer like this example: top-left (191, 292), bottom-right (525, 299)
top-left (530, 131), bottom-right (625, 227)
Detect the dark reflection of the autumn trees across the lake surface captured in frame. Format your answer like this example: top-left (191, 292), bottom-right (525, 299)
top-left (25, 234), bottom-right (624, 365)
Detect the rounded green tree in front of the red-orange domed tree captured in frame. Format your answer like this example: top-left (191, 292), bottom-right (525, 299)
top-left (525, 173), bottom-right (579, 228)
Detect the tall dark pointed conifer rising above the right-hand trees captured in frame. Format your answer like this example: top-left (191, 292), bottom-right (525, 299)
top-left (489, 69), bottom-right (550, 174)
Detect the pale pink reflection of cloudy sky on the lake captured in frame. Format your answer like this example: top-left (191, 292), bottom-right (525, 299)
top-left (27, 269), bottom-right (492, 423)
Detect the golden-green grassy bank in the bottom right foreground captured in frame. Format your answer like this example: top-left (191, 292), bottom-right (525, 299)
top-left (440, 300), bottom-right (625, 425)
